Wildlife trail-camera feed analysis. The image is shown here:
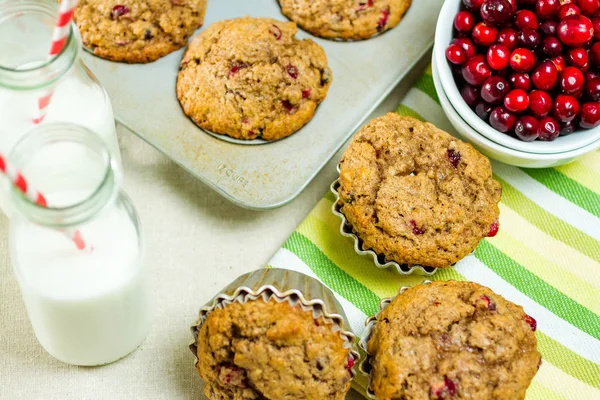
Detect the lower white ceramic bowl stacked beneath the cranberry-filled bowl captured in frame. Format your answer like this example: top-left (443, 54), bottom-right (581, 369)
top-left (432, 52), bottom-right (600, 168)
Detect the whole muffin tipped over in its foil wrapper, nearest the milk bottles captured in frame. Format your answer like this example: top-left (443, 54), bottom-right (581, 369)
top-left (190, 268), bottom-right (358, 400)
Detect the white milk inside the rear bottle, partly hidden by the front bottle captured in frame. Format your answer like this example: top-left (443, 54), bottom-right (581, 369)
top-left (0, 68), bottom-right (121, 216)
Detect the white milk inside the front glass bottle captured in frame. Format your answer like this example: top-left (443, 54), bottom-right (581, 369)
top-left (10, 192), bottom-right (152, 366)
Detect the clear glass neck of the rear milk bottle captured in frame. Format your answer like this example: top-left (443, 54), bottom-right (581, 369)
top-left (0, 0), bottom-right (81, 91)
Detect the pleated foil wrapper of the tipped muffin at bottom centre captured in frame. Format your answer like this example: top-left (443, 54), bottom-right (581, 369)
top-left (190, 268), bottom-right (359, 378)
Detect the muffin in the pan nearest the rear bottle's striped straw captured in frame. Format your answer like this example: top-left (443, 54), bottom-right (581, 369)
top-left (73, 0), bottom-right (207, 63)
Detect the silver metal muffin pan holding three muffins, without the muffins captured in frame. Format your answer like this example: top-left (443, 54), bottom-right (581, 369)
top-left (83, 0), bottom-right (443, 209)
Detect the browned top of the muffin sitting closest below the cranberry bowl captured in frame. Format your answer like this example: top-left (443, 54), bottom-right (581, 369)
top-left (338, 113), bottom-right (501, 268)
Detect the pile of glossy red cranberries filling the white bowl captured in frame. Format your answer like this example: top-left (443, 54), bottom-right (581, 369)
top-left (446, 0), bottom-right (600, 142)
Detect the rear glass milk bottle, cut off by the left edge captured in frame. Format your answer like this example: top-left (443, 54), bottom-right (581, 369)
top-left (0, 0), bottom-right (120, 216)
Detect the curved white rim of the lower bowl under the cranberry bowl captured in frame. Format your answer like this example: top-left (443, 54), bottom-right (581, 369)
top-left (432, 53), bottom-right (600, 162)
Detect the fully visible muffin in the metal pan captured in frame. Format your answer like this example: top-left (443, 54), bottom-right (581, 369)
top-left (177, 18), bottom-right (332, 140)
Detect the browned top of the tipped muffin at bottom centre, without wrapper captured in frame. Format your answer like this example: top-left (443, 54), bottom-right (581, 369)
top-left (197, 298), bottom-right (353, 400)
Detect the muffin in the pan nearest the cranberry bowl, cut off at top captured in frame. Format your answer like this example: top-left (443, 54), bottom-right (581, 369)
top-left (279, 0), bottom-right (411, 40)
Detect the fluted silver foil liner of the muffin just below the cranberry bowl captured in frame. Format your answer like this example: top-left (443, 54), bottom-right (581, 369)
top-left (331, 165), bottom-right (437, 275)
